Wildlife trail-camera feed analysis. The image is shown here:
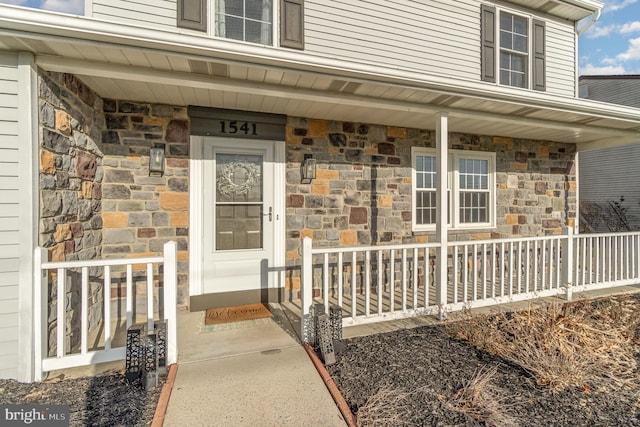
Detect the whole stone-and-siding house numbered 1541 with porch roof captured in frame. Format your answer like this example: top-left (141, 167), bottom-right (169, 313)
top-left (0, 0), bottom-right (640, 380)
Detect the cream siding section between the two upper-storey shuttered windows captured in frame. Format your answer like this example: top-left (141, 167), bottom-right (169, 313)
top-left (305, 0), bottom-right (480, 80)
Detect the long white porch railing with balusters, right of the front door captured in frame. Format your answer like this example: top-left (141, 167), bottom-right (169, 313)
top-left (301, 228), bottom-right (640, 339)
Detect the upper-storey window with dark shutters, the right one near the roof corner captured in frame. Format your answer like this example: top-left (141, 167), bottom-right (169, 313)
top-left (481, 5), bottom-right (546, 90)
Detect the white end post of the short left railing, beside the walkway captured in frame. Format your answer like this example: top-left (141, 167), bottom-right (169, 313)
top-left (163, 242), bottom-right (178, 366)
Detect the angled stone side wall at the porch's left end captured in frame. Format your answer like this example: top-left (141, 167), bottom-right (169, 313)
top-left (38, 73), bottom-right (104, 351)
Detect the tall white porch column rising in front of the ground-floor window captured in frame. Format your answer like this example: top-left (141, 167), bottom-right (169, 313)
top-left (436, 113), bottom-right (449, 320)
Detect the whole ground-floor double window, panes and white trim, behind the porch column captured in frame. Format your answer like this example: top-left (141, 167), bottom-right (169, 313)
top-left (411, 147), bottom-right (496, 231)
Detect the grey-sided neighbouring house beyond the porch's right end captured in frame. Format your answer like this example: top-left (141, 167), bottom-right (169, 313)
top-left (579, 75), bottom-right (640, 232)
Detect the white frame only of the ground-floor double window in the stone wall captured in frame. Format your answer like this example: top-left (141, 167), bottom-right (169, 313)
top-left (411, 147), bottom-right (497, 231)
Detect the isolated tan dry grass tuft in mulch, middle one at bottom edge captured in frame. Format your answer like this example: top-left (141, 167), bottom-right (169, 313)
top-left (447, 366), bottom-right (519, 427)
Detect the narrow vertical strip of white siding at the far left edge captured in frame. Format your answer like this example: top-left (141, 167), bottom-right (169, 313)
top-left (0, 52), bottom-right (20, 378)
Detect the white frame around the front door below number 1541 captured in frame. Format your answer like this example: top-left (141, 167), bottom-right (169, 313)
top-left (189, 135), bottom-right (286, 296)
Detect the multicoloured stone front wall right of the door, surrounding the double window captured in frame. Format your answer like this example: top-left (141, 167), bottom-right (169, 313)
top-left (286, 117), bottom-right (576, 289)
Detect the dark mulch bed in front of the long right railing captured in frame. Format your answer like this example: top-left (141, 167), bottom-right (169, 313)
top-left (327, 296), bottom-right (640, 426)
